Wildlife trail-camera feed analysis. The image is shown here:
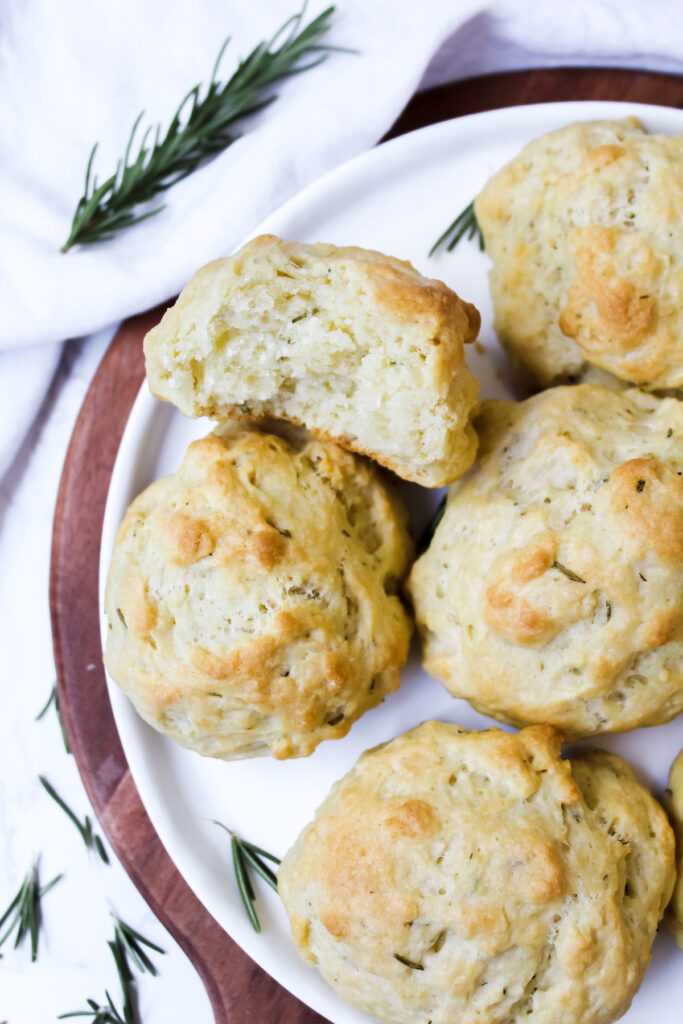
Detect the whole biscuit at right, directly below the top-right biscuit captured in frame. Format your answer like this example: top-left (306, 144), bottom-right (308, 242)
top-left (409, 384), bottom-right (683, 737)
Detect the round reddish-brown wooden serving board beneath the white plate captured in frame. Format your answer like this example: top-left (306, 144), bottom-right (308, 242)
top-left (50, 69), bottom-right (683, 1024)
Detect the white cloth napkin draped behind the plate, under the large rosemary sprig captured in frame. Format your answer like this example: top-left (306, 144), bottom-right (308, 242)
top-left (0, 0), bottom-right (683, 473)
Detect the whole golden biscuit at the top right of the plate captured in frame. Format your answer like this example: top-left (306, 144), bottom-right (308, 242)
top-left (475, 118), bottom-right (683, 389)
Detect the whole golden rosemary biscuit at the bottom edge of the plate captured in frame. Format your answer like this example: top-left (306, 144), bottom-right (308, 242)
top-left (278, 722), bottom-right (674, 1024)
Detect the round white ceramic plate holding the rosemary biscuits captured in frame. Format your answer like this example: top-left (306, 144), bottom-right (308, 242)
top-left (100, 102), bottom-right (683, 1024)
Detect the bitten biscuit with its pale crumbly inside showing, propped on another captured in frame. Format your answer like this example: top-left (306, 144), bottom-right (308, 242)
top-left (144, 236), bottom-right (479, 486)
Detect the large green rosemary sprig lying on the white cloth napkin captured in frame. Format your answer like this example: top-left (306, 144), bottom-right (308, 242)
top-left (61, 3), bottom-right (341, 252)
